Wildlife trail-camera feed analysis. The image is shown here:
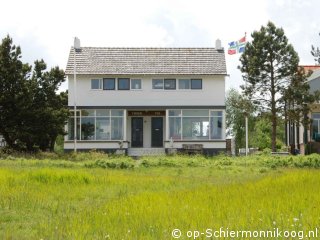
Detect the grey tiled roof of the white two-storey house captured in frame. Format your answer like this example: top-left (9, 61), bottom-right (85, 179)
top-left (66, 47), bottom-right (227, 75)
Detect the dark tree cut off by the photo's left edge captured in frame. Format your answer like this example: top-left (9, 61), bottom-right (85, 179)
top-left (0, 36), bottom-right (31, 148)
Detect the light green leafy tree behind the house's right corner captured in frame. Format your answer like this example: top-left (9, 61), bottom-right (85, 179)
top-left (226, 89), bottom-right (254, 152)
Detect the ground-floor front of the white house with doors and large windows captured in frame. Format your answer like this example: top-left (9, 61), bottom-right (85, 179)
top-left (65, 107), bottom-right (226, 156)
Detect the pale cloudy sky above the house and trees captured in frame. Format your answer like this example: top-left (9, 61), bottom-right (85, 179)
top-left (0, 0), bottom-right (320, 91)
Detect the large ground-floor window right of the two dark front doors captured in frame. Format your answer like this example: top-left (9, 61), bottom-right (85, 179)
top-left (169, 109), bottom-right (224, 140)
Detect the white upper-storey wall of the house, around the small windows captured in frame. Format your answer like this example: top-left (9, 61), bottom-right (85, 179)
top-left (68, 75), bottom-right (225, 106)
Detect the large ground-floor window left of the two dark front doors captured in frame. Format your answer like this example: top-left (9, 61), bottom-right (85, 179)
top-left (68, 109), bottom-right (124, 141)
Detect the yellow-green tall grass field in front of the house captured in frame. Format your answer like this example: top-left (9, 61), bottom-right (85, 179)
top-left (0, 153), bottom-right (320, 240)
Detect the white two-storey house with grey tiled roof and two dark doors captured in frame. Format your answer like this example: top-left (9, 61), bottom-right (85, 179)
top-left (64, 42), bottom-right (227, 154)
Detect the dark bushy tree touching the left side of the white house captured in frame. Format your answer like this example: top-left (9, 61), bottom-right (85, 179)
top-left (23, 60), bottom-right (69, 151)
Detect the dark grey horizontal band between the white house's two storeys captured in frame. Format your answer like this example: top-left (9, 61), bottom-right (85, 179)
top-left (69, 105), bottom-right (226, 110)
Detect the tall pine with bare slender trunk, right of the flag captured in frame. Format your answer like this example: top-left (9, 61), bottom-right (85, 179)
top-left (239, 22), bottom-right (299, 151)
